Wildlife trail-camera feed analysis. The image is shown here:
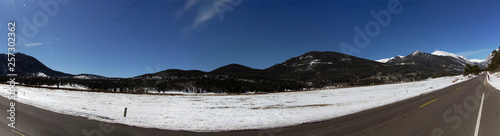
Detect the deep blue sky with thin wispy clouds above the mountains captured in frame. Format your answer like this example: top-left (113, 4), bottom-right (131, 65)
top-left (0, 0), bottom-right (500, 77)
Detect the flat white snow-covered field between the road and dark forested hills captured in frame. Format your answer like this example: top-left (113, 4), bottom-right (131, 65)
top-left (0, 76), bottom-right (467, 132)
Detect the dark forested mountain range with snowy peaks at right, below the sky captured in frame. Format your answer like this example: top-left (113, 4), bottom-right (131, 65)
top-left (0, 48), bottom-right (493, 92)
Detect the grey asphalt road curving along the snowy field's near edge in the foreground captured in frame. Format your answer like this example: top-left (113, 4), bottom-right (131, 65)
top-left (0, 75), bottom-right (500, 136)
